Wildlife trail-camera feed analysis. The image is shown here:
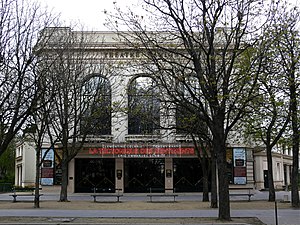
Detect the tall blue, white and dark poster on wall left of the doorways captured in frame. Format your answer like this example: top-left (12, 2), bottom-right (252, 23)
top-left (41, 149), bottom-right (54, 185)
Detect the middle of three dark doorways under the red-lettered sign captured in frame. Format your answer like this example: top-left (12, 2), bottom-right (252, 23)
top-left (124, 159), bottom-right (165, 193)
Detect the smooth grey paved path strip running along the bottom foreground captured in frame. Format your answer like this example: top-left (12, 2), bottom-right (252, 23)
top-left (0, 209), bottom-right (300, 225)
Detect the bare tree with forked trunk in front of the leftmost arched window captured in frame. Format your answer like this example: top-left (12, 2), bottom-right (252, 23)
top-left (41, 27), bottom-right (111, 201)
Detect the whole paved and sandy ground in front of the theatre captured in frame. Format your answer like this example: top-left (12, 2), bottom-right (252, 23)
top-left (0, 188), bottom-right (300, 225)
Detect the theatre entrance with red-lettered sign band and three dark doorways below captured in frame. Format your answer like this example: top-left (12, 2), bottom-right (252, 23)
top-left (70, 143), bottom-right (202, 192)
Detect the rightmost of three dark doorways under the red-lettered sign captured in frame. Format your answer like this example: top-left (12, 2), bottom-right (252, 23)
top-left (173, 158), bottom-right (211, 192)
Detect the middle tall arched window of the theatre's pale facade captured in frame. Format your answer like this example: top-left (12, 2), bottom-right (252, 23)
top-left (128, 77), bottom-right (160, 135)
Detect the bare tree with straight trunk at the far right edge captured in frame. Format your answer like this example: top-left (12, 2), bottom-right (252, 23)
top-left (272, 5), bottom-right (300, 208)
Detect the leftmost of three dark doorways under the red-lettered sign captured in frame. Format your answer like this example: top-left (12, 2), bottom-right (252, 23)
top-left (75, 159), bottom-right (115, 193)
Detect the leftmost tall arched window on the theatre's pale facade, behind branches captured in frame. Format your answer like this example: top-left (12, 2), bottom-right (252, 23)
top-left (81, 76), bottom-right (111, 135)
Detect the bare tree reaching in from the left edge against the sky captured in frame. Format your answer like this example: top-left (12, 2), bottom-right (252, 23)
top-left (0, 0), bottom-right (54, 155)
